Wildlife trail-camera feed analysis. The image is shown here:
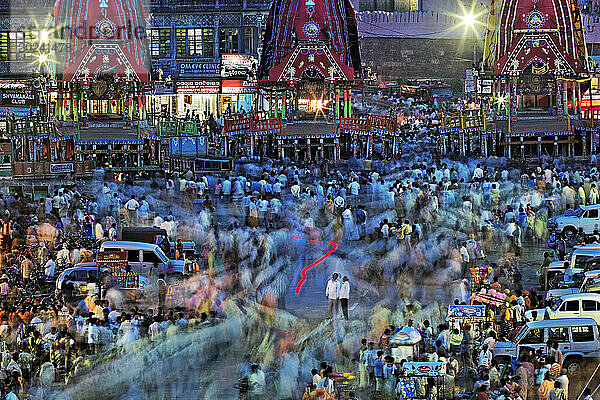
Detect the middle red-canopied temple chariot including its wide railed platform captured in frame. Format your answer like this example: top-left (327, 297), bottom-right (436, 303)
top-left (223, 0), bottom-right (404, 162)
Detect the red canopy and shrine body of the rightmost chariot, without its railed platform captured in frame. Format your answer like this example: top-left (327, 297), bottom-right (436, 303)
top-left (483, 0), bottom-right (589, 118)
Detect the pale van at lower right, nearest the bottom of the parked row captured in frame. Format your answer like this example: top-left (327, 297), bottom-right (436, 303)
top-left (494, 318), bottom-right (600, 376)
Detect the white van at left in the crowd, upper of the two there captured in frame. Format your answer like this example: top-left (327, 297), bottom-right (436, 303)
top-left (100, 241), bottom-right (185, 276)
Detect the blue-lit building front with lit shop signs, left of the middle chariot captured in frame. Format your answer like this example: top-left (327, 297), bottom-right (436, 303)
top-left (146, 0), bottom-right (270, 117)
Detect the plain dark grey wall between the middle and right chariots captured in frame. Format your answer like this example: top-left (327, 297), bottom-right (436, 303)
top-left (361, 37), bottom-right (482, 81)
